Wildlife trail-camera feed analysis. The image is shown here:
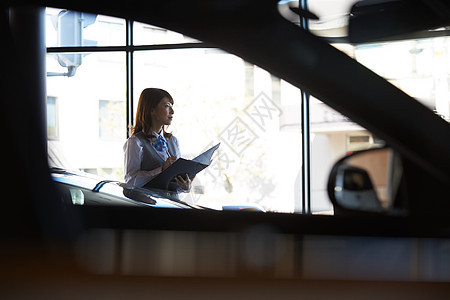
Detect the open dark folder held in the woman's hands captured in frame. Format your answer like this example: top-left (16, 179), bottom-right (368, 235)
top-left (144, 143), bottom-right (220, 190)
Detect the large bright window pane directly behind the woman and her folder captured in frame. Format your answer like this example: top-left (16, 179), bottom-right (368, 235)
top-left (134, 48), bottom-right (301, 212)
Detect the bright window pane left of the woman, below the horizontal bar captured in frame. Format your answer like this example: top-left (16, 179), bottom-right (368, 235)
top-left (47, 52), bottom-right (126, 180)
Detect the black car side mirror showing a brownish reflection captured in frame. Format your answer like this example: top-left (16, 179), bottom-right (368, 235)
top-left (328, 148), bottom-right (403, 214)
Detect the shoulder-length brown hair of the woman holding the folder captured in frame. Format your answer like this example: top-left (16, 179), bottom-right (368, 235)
top-left (131, 88), bottom-right (173, 138)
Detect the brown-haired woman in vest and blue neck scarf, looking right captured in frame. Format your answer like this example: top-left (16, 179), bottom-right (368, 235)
top-left (123, 88), bottom-right (191, 190)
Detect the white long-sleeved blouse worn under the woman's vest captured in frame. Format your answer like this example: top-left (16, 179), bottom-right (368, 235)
top-left (123, 132), bottom-right (180, 187)
